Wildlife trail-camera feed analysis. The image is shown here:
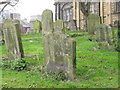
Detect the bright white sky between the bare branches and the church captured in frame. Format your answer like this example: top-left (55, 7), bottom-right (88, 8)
top-left (10, 0), bottom-right (55, 19)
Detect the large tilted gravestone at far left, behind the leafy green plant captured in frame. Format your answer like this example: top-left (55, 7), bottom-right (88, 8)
top-left (3, 19), bottom-right (24, 60)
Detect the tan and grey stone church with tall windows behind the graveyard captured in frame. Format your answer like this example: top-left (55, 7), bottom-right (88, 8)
top-left (54, 0), bottom-right (120, 30)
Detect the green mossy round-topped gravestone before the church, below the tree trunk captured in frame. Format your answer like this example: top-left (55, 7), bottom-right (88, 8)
top-left (87, 14), bottom-right (100, 35)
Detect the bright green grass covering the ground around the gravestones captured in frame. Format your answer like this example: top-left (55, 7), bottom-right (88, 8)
top-left (2, 32), bottom-right (118, 88)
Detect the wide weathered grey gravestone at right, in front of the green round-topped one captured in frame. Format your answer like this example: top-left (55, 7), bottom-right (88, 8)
top-left (94, 24), bottom-right (114, 49)
